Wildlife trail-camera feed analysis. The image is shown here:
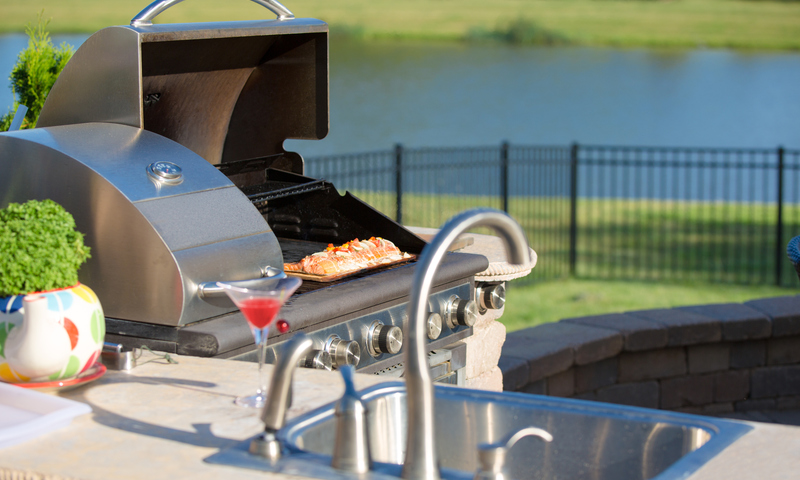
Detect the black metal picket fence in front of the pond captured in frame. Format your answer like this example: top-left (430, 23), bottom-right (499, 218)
top-left (306, 143), bottom-right (800, 285)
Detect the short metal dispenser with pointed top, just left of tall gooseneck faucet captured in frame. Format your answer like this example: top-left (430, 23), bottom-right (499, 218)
top-left (331, 365), bottom-right (371, 473)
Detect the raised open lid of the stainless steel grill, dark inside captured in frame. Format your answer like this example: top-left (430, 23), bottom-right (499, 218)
top-left (38, 15), bottom-right (329, 174)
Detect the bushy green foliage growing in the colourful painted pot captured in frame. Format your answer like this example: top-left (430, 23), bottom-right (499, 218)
top-left (0, 200), bottom-right (91, 298)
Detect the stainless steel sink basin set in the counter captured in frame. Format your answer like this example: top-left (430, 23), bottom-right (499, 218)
top-left (205, 382), bottom-right (751, 480)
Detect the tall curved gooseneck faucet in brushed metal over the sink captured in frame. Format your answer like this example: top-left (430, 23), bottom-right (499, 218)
top-left (402, 208), bottom-right (530, 480)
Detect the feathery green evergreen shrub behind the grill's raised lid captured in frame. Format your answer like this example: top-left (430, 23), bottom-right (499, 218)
top-left (0, 12), bottom-right (73, 131)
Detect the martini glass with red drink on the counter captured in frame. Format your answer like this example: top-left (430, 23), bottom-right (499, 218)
top-left (217, 277), bottom-right (303, 408)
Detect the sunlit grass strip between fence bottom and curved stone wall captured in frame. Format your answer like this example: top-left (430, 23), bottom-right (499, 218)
top-left (500, 279), bottom-right (800, 331)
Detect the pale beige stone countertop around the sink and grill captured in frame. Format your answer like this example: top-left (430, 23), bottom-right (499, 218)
top-left (0, 353), bottom-right (800, 480)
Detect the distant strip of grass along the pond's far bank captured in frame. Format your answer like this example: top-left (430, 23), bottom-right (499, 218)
top-left (0, 0), bottom-right (800, 49)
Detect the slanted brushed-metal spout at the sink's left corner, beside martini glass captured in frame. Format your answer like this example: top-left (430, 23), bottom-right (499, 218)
top-left (250, 332), bottom-right (314, 461)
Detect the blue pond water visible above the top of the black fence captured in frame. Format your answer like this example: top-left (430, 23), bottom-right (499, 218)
top-left (0, 35), bottom-right (800, 156)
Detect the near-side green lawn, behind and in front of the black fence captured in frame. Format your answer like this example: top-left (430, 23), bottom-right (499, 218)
top-left (338, 186), bottom-right (800, 331)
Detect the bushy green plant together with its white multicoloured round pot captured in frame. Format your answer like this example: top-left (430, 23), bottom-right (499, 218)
top-left (0, 200), bottom-right (105, 383)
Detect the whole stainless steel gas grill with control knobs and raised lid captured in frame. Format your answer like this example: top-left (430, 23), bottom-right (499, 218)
top-left (0, 0), bottom-right (488, 381)
